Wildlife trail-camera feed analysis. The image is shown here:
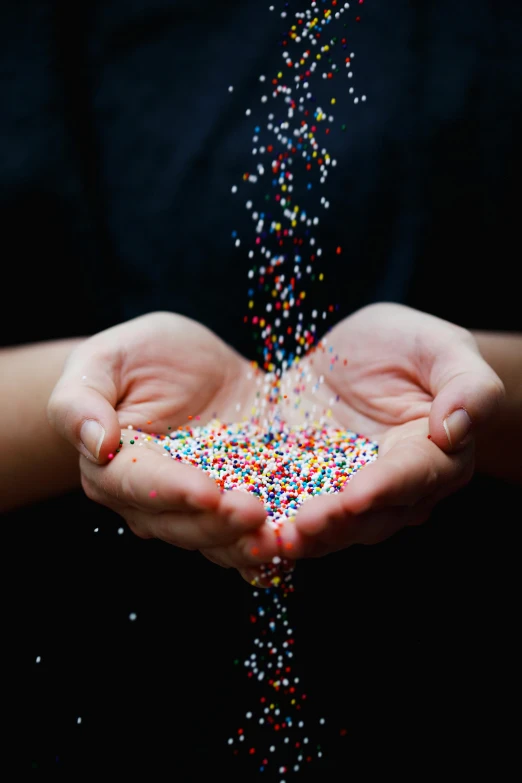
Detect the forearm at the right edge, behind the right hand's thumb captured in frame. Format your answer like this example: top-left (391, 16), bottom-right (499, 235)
top-left (473, 331), bottom-right (522, 484)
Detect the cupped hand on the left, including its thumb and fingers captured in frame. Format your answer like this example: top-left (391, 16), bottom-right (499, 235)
top-left (48, 313), bottom-right (277, 566)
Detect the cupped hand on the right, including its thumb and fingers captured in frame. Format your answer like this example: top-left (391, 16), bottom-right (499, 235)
top-left (266, 304), bottom-right (504, 564)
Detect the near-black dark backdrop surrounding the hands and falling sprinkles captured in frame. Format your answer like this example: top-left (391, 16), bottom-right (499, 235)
top-left (0, 0), bottom-right (522, 781)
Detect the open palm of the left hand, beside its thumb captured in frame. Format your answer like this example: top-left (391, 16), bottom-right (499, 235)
top-left (98, 313), bottom-right (256, 432)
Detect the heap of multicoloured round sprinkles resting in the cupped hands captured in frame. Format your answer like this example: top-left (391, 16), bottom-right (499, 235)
top-left (161, 421), bottom-right (377, 531)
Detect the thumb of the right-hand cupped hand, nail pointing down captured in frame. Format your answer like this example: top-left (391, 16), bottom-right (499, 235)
top-left (430, 335), bottom-right (505, 452)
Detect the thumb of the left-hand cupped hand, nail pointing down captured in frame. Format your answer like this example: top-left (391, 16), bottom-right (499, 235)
top-left (47, 341), bottom-right (121, 463)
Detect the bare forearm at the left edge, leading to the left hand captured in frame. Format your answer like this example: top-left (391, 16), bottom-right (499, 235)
top-left (0, 339), bottom-right (85, 513)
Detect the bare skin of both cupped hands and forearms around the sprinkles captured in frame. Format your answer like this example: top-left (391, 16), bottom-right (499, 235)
top-left (0, 304), bottom-right (522, 581)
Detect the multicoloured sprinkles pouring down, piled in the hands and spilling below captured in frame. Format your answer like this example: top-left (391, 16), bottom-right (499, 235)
top-left (212, 0), bottom-right (370, 783)
